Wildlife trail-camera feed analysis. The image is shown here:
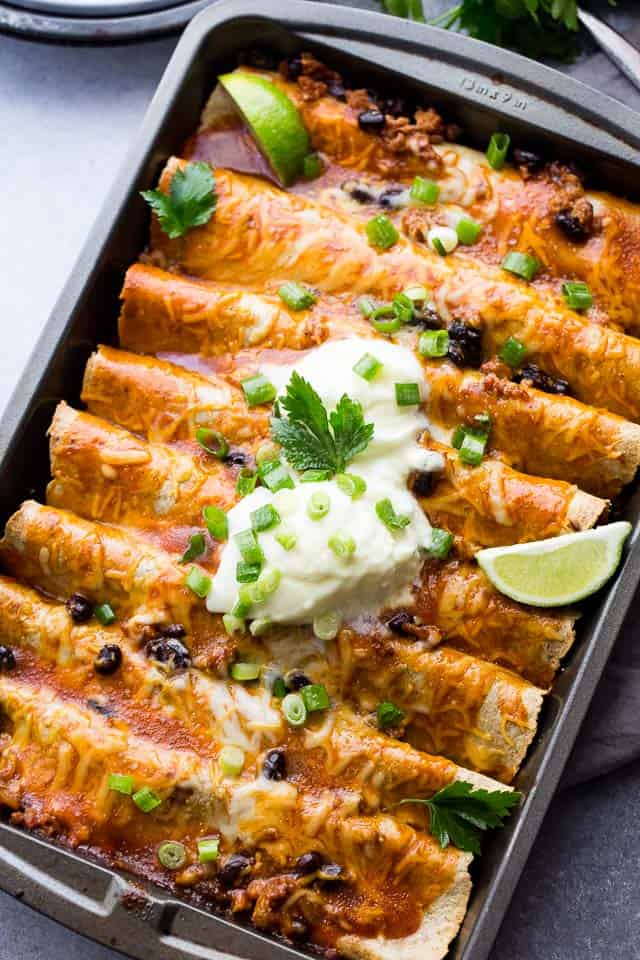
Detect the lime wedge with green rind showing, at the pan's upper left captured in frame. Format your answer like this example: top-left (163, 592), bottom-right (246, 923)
top-left (220, 72), bottom-right (311, 187)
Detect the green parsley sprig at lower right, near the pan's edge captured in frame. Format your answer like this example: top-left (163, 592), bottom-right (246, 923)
top-left (400, 780), bottom-right (522, 853)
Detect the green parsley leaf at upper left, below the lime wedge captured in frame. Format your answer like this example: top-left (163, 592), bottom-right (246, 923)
top-left (142, 161), bottom-right (217, 240)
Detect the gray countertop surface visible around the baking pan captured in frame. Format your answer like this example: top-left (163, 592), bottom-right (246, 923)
top-left (0, 2), bottom-right (640, 960)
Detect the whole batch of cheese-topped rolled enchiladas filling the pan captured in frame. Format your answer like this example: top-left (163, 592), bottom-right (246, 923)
top-left (0, 50), bottom-right (640, 958)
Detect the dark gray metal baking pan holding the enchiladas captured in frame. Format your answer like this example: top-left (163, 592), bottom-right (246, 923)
top-left (0, 0), bottom-right (640, 960)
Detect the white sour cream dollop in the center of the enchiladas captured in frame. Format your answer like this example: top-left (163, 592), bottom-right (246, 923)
top-left (207, 337), bottom-right (443, 624)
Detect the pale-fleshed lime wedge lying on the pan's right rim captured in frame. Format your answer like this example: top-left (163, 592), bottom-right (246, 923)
top-left (476, 522), bottom-right (631, 607)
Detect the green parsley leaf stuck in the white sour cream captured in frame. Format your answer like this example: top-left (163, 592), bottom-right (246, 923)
top-left (271, 371), bottom-right (374, 476)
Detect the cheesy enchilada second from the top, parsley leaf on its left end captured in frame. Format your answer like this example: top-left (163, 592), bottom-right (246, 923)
top-left (152, 158), bottom-right (640, 420)
